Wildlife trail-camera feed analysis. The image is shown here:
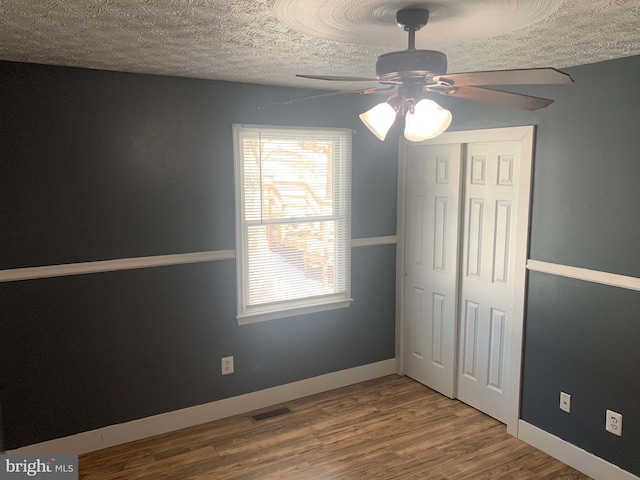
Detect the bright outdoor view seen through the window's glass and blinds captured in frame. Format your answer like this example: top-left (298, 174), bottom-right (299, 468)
top-left (243, 135), bottom-right (340, 305)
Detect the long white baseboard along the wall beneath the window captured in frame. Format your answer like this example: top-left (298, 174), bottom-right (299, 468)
top-left (7, 358), bottom-right (396, 455)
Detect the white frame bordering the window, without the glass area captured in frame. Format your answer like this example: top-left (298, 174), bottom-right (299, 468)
top-left (232, 124), bottom-right (353, 325)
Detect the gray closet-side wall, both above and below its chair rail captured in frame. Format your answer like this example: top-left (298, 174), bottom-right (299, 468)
top-left (446, 56), bottom-right (640, 475)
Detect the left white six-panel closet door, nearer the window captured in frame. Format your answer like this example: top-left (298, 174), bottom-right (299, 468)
top-left (403, 144), bottom-right (461, 398)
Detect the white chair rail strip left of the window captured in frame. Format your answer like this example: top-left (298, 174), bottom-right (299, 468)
top-left (0, 250), bottom-right (236, 282)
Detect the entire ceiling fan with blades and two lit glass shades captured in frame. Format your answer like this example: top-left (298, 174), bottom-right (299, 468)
top-left (296, 8), bottom-right (573, 141)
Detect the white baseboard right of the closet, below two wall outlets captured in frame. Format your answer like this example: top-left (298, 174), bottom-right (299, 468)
top-left (518, 420), bottom-right (640, 480)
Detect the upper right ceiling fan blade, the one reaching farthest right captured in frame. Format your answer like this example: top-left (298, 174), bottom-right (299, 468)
top-left (433, 68), bottom-right (573, 87)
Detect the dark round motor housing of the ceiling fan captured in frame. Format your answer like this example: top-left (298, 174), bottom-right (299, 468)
top-left (376, 50), bottom-right (447, 81)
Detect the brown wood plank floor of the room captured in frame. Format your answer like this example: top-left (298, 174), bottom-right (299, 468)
top-left (79, 375), bottom-right (589, 480)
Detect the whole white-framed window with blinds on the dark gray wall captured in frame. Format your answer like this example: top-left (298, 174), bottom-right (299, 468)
top-left (233, 125), bottom-right (351, 323)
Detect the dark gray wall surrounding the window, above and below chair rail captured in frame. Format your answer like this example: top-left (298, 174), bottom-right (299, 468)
top-left (0, 62), bottom-right (397, 449)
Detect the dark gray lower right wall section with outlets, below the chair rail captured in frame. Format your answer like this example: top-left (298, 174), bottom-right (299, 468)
top-left (522, 272), bottom-right (640, 475)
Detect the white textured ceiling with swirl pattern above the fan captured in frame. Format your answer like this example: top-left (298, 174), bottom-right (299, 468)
top-left (0, 0), bottom-right (640, 89)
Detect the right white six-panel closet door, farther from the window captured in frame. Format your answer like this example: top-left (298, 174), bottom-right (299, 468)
top-left (458, 142), bottom-right (526, 423)
